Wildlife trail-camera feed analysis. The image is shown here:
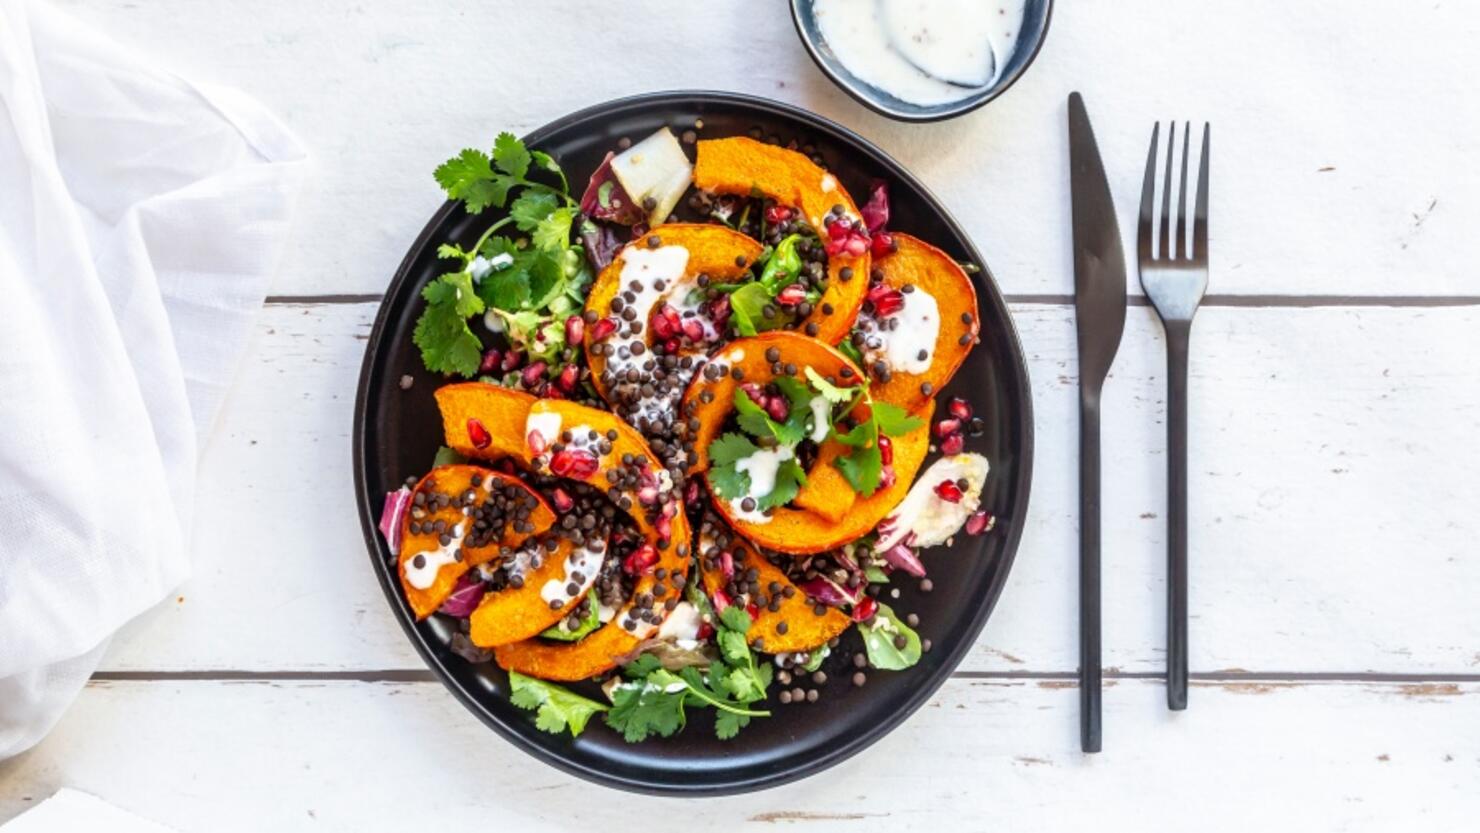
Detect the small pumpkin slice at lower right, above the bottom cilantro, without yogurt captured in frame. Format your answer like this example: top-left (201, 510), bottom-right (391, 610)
top-left (699, 533), bottom-right (852, 654)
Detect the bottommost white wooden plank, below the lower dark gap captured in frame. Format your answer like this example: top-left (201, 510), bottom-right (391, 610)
top-left (0, 681), bottom-right (1480, 833)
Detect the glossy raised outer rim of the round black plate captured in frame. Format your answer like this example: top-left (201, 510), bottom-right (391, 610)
top-left (351, 89), bottom-right (1035, 797)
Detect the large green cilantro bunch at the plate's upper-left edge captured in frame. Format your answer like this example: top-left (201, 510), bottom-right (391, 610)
top-left (413, 133), bottom-right (591, 382)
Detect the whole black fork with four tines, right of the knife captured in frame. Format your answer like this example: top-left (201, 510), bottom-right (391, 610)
top-left (1137, 121), bottom-right (1211, 712)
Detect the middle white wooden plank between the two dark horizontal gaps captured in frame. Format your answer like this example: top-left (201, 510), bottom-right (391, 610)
top-left (105, 305), bottom-right (1480, 673)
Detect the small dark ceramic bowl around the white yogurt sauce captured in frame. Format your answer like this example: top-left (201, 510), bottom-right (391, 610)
top-left (792, 0), bottom-right (1054, 121)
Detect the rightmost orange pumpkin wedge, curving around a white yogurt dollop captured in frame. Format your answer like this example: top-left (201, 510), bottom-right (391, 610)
top-left (869, 232), bottom-right (980, 411)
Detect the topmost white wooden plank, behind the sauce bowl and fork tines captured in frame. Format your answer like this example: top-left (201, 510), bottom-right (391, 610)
top-left (54, 0), bottom-right (1480, 296)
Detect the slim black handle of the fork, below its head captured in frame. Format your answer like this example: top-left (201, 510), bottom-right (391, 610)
top-left (1166, 321), bottom-right (1191, 712)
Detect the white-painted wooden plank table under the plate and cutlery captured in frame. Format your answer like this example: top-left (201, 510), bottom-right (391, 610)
top-left (0, 0), bottom-right (1480, 832)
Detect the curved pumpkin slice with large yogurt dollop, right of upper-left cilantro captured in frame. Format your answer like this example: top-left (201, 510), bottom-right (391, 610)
top-left (585, 223), bottom-right (761, 408)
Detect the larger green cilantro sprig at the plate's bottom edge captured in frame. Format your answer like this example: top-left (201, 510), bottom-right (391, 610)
top-left (605, 605), bottom-right (771, 743)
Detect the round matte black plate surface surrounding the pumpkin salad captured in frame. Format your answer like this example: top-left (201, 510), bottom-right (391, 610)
top-left (354, 92), bottom-right (1033, 795)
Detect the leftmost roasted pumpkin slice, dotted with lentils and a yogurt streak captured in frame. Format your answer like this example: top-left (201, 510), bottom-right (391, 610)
top-left (400, 466), bottom-right (555, 618)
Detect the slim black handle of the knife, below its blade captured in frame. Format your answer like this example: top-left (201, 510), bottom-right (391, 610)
top-left (1079, 394), bottom-right (1101, 752)
